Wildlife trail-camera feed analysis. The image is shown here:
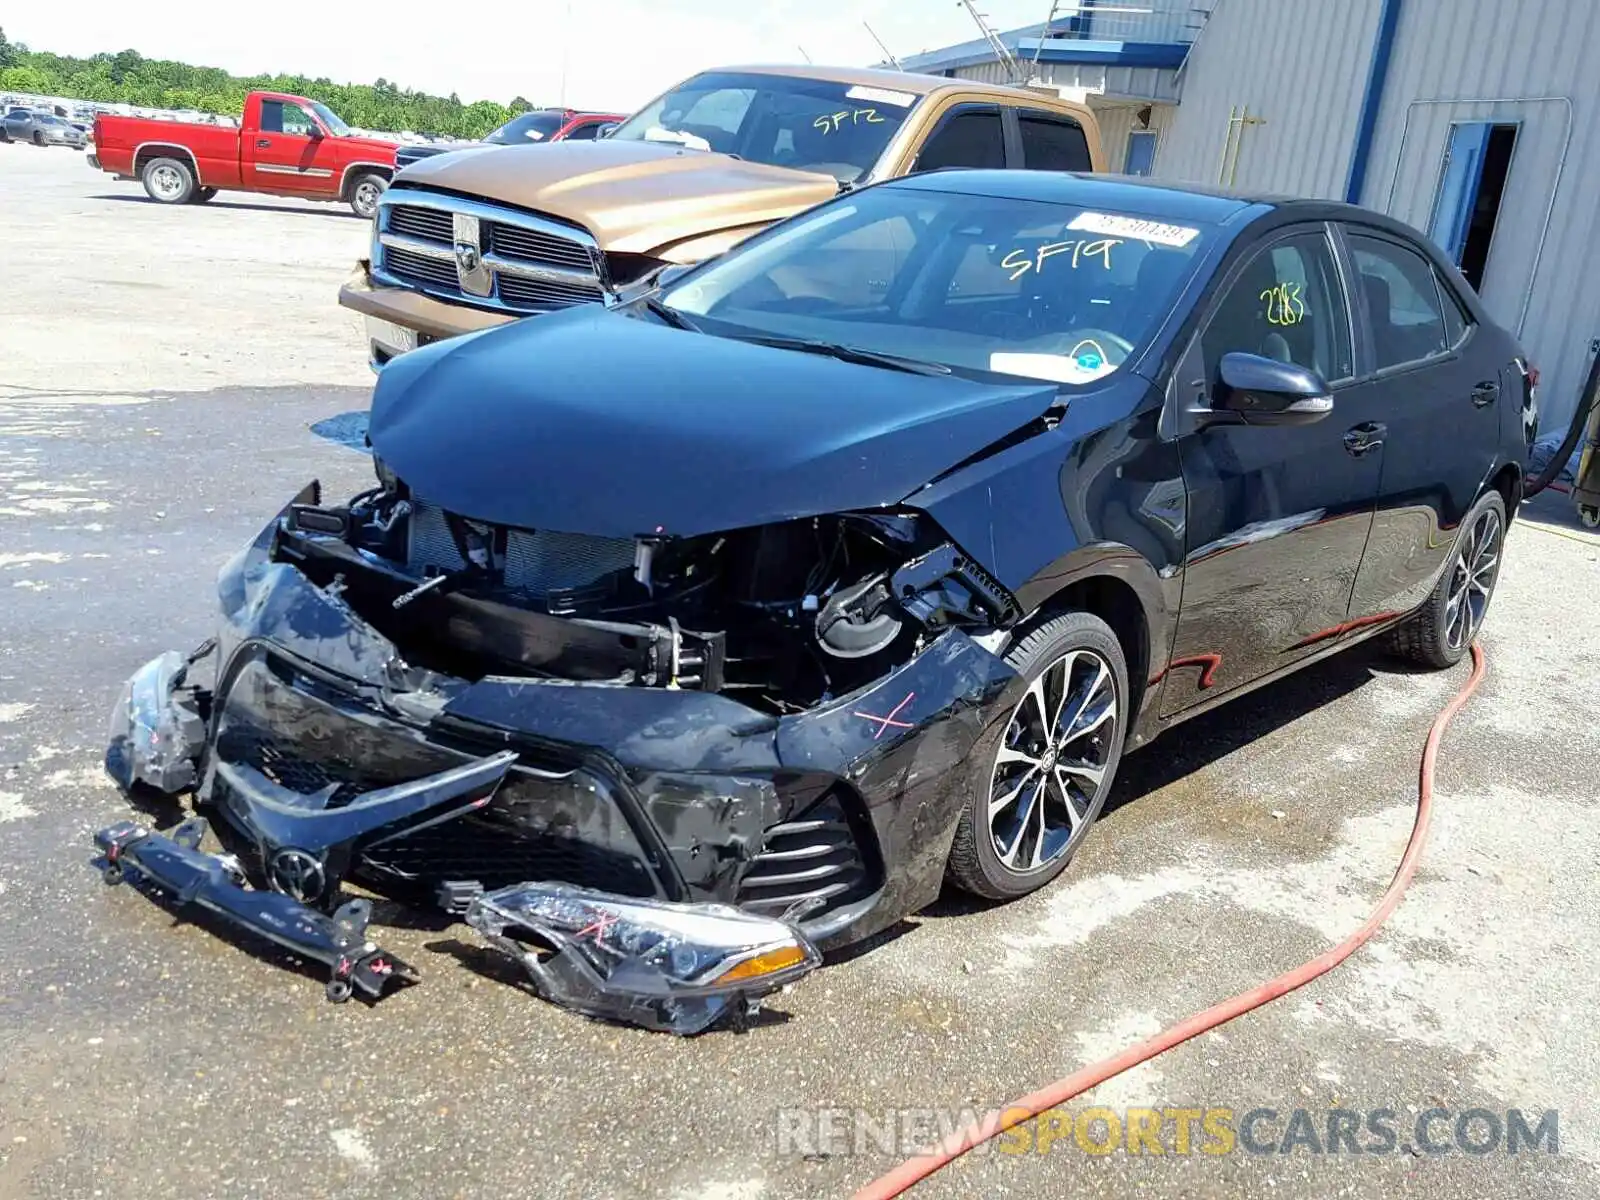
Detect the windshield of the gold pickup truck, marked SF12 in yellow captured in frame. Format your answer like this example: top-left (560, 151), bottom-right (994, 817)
top-left (611, 70), bottom-right (920, 184)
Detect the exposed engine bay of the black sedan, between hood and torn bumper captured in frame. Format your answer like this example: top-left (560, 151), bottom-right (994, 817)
top-left (277, 462), bottom-right (1014, 714)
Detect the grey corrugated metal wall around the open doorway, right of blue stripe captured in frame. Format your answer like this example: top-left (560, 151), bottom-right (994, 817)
top-left (1363, 0), bottom-right (1600, 435)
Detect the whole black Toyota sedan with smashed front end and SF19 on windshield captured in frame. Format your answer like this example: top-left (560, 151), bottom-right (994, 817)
top-left (101, 171), bottom-right (1534, 1032)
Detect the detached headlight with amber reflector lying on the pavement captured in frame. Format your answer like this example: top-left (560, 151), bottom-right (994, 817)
top-left (467, 883), bottom-right (822, 1035)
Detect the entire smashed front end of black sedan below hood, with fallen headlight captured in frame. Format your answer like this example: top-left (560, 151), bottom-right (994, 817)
top-left (101, 461), bottom-right (1018, 1032)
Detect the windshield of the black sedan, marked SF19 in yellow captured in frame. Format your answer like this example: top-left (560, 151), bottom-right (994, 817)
top-left (659, 186), bottom-right (1210, 384)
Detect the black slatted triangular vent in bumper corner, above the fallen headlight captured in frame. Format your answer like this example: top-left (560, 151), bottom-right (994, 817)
top-left (736, 792), bottom-right (872, 920)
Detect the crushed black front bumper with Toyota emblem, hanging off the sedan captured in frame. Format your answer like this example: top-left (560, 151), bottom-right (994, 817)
top-left (107, 490), bottom-right (1021, 1019)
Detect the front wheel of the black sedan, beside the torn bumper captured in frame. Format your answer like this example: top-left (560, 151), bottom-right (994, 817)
top-left (946, 613), bottom-right (1131, 899)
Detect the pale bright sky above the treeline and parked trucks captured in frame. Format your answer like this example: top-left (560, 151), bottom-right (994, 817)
top-left (9, 0), bottom-right (1050, 110)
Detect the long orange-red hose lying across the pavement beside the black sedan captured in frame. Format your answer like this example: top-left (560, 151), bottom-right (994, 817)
top-left (854, 646), bottom-right (1483, 1200)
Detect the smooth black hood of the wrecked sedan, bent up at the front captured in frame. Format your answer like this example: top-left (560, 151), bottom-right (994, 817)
top-left (370, 306), bottom-right (1056, 538)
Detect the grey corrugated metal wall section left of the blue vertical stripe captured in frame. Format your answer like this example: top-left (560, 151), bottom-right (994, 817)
top-left (1155, 0), bottom-right (1381, 198)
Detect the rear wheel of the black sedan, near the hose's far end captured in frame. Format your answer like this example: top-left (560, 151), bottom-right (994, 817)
top-left (1389, 491), bottom-right (1506, 670)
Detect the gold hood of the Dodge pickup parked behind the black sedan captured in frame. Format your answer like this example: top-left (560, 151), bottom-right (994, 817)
top-left (388, 141), bottom-right (838, 254)
